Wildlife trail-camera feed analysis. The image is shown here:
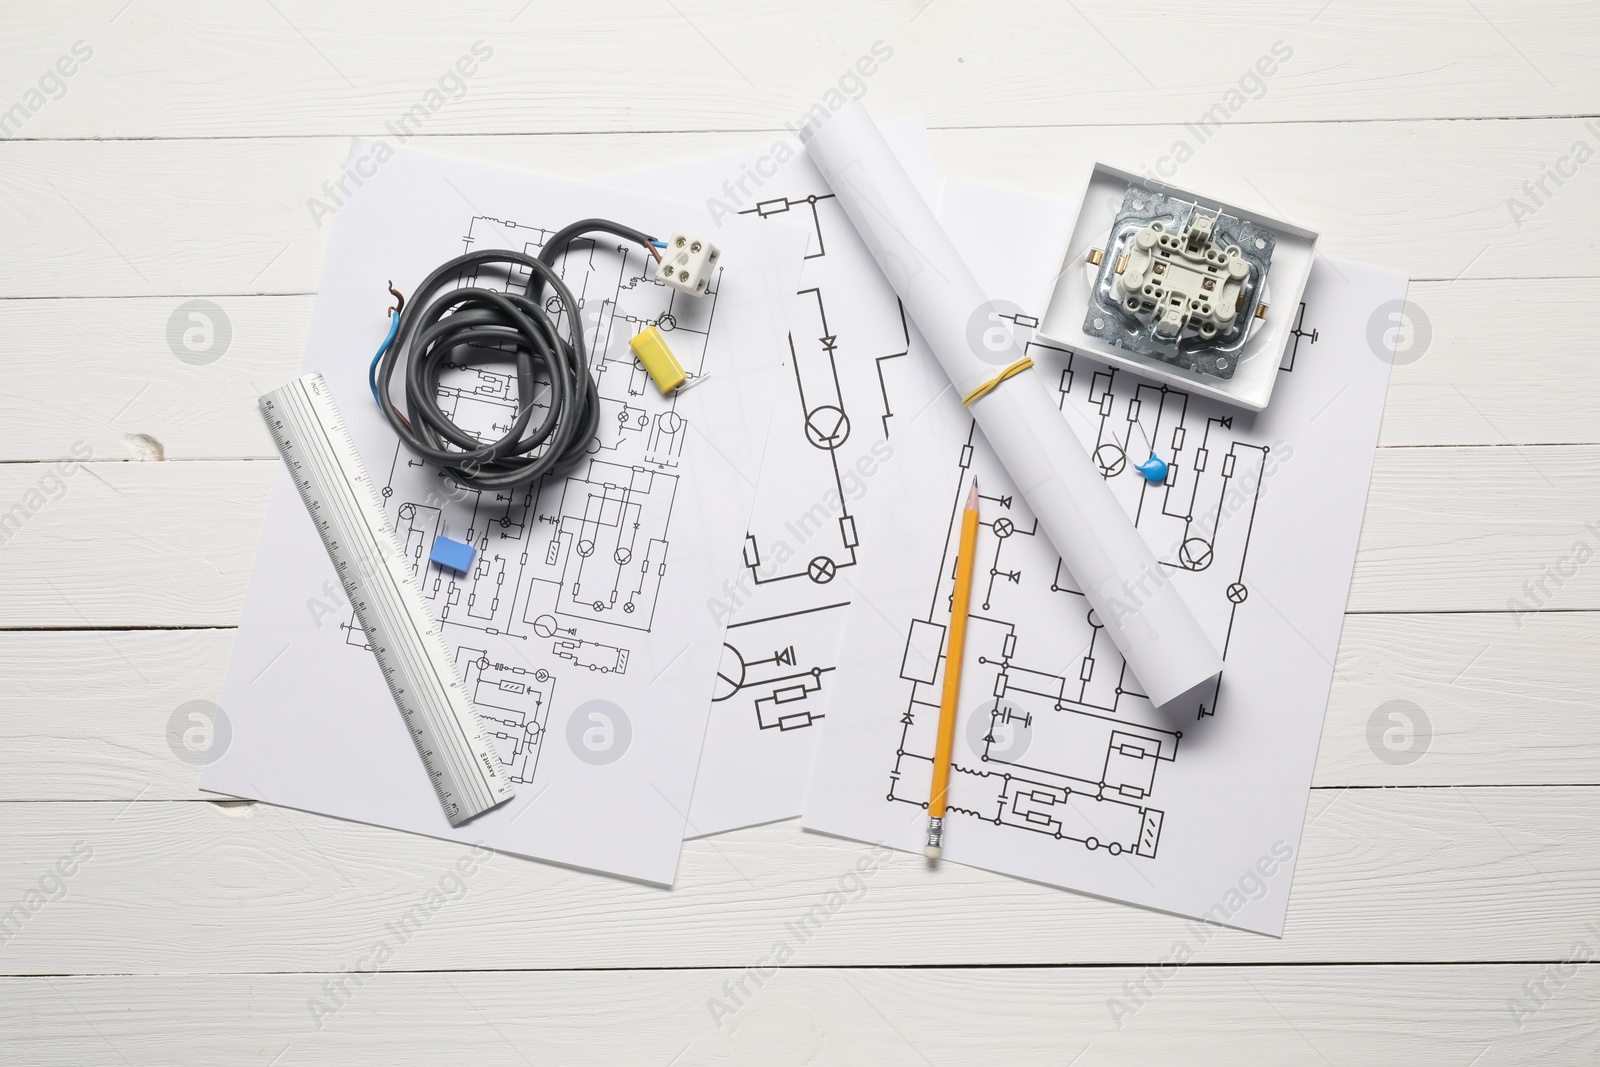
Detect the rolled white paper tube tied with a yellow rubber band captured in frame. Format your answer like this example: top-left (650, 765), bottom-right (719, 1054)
top-left (800, 101), bottom-right (1222, 704)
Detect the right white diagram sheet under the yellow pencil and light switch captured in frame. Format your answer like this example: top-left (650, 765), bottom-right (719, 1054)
top-left (805, 182), bottom-right (1406, 936)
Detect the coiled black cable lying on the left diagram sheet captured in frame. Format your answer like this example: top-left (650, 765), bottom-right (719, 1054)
top-left (374, 219), bottom-right (659, 490)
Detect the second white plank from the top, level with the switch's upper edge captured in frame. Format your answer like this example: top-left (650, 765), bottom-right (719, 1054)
top-left (0, 117), bottom-right (1600, 300)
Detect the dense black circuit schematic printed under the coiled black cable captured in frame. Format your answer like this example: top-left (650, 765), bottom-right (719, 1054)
top-left (342, 216), bottom-right (717, 782)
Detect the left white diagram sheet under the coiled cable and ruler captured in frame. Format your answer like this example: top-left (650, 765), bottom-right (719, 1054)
top-left (202, 142), bottom-right (806, 885)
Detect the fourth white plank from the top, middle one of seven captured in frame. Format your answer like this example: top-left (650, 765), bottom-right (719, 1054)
top-left (0, 445), bottom-right (1600, 627)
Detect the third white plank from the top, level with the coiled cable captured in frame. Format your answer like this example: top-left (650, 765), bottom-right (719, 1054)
top-left (0, 278), bottom-right (1580, 461)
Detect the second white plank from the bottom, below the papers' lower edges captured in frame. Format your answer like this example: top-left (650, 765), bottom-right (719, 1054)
top-left (0, 787), bottom-right (1600, 974)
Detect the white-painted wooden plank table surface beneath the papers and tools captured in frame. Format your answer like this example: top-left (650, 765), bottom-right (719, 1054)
top-left (0, 0), bottom-right (1600, 1067)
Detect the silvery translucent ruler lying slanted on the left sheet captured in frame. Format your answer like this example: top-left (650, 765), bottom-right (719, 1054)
top-left (261, 374), bottom-right (512, 825)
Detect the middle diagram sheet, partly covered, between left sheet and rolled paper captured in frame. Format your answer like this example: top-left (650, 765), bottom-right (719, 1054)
top-left (613, 120), bottom-right (938, 837)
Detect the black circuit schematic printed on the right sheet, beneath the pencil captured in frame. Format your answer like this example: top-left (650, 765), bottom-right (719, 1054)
top-left (886, 307), bottom-right (1317, 857)
